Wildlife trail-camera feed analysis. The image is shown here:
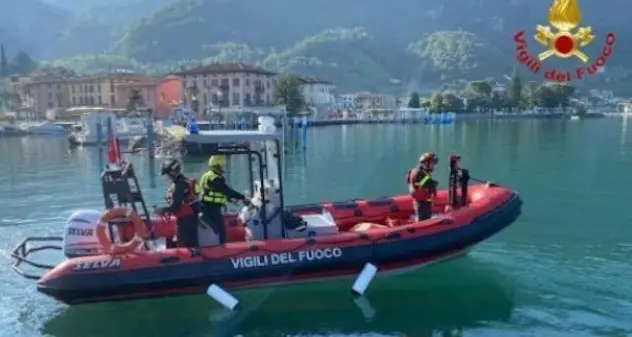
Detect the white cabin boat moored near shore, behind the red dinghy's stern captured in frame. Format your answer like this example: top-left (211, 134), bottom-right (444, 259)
top-left (68, 111), bottom-right (147, 146)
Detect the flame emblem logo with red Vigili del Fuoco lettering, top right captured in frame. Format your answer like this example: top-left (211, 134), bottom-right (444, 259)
top-left (514, 0), bottom-right (615, 82)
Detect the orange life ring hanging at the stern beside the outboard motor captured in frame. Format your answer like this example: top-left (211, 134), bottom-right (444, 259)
top-left (96, 208), bottom-right (147, 254)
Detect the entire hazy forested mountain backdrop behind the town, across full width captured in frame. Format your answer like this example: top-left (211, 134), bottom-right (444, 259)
top-left (0, 0), bottom-right (632, 90)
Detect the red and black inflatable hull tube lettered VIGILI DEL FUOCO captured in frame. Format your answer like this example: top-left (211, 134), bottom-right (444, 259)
top-left (38, 187), bottom-right (522, 304)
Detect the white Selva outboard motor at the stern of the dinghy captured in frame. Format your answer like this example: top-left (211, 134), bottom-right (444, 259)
top-left (62, 209), bottom-right (102, 258)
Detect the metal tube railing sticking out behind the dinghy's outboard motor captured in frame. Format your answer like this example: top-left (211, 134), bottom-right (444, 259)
top-left (10, 236), bottom-right (63, 280)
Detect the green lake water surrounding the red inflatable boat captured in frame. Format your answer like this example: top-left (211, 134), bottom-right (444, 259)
top-left (0, 118), bottom-right (632, 337)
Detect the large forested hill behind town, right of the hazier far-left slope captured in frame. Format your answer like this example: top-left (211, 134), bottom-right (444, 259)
top-left (113, 0), bottom-right (632, 90)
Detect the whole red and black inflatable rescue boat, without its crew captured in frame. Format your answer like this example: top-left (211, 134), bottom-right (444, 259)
top-left (12, 117), bottom-right (522, 304)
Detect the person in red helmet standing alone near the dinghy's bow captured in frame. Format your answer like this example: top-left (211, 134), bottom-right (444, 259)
top-left (407, 152), bottom-right (439, 221)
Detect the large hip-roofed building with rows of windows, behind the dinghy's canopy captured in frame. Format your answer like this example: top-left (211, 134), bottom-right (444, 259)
top-left (176, 63), bottom-right (277, 108)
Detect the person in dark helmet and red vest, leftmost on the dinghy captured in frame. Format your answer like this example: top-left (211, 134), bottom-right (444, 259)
top-left (156, 160), bottom-right (201, 248)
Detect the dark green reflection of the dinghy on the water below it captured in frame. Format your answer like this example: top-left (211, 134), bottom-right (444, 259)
top-left (43, 257), bottom-right (514, 337)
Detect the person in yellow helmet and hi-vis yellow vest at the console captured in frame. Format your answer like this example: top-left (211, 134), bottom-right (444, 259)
top-left (199, 155), bottom-right (250, 244)
